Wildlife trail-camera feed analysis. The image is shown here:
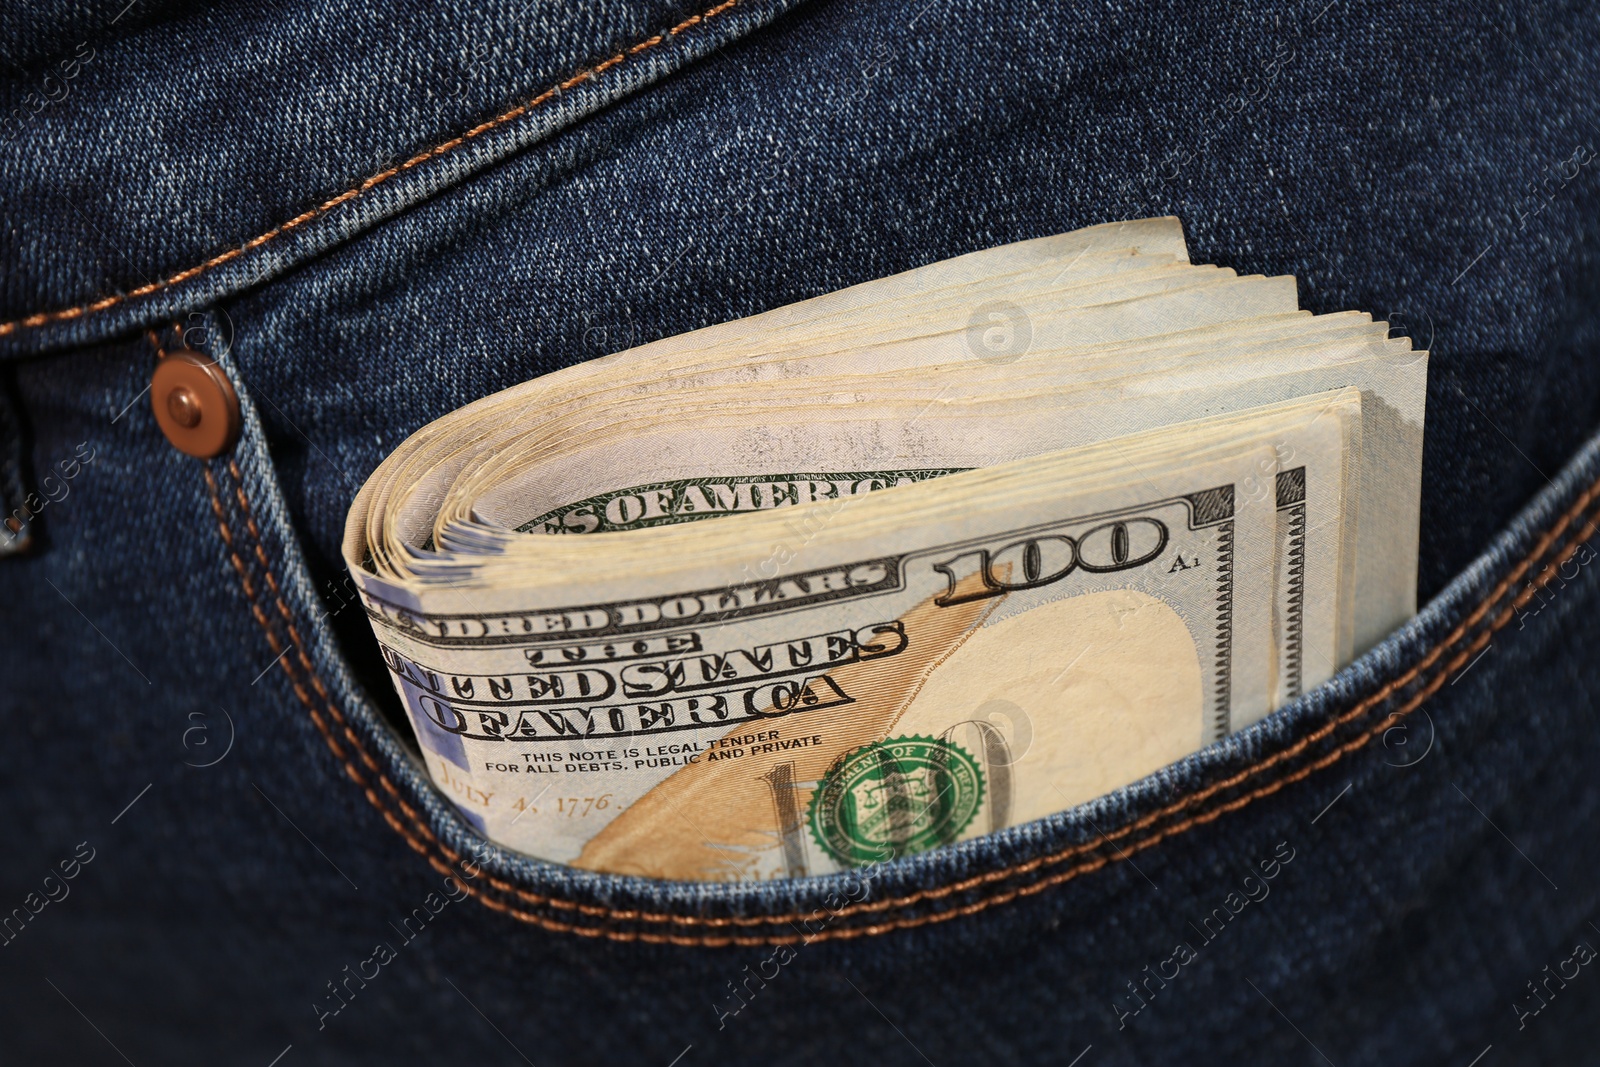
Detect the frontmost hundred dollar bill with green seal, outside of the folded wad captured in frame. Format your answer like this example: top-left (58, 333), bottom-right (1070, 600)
top-left (358, 390), bottom-right (1360, 880)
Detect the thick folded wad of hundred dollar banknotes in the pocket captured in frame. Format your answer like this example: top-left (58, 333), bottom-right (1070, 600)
top-left (344, 212), bottom-right (1427, 880)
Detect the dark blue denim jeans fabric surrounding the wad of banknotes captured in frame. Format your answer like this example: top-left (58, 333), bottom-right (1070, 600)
top-left (0, 0), bottom-right (1600, 1067)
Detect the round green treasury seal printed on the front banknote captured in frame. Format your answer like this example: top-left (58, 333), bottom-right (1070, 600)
top-left (810, 737), bottom-right (984, 867)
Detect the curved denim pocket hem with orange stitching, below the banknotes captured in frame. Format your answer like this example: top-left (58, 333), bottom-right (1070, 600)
top-left (218, 383), bottom-right (1600, 945)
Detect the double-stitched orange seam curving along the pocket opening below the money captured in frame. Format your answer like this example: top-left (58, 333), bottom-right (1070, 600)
top-left (203, 461), bottom-right (1600, 947)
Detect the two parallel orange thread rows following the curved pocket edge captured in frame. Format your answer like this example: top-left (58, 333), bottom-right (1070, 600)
top-left (205, 461), bottom-right (1600, 947)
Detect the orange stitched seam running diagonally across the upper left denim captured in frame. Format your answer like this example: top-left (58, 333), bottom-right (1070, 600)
top-left (0, 0), bottom-right (742, 338)
